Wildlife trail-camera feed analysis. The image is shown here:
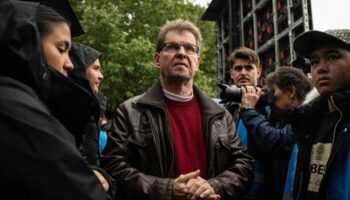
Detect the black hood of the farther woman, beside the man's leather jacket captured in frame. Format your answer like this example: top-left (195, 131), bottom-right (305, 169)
top-left (68, 43), bottom-right (102, 88)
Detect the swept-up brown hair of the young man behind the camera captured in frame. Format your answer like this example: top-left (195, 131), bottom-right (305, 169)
top-left (227, 47), bottom-right (260, 67)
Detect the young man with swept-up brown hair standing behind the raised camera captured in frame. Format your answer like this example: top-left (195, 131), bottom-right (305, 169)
top-left (224, 47), bottom-right (273, 199)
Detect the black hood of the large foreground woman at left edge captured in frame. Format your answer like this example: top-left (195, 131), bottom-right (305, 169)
top-left (0, 0), bottom-right (50, 99)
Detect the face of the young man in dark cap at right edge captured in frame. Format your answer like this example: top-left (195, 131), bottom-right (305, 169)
top-left (310, 44), bottom-right (350, 95)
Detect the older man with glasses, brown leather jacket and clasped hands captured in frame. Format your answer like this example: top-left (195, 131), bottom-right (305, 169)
top-left (102, 20), bottom-right (252, 200)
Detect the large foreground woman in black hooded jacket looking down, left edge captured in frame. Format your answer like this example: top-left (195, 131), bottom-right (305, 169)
top-left (0, 0), bottom-right (107, 200)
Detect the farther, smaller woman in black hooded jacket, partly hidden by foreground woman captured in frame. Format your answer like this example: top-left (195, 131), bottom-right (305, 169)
top-left (68, 43), bottom-right (114, 194)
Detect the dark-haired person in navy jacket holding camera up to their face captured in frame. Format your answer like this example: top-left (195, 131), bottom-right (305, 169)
top-left (240, 66), bottom-right (312, 199)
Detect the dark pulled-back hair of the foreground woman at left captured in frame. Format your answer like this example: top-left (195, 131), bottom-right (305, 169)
top-left (36, 5), bottom-right (70, 37)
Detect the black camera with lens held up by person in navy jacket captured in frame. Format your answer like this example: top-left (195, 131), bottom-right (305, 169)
top-left (218, 83), bottom-right (273, 105)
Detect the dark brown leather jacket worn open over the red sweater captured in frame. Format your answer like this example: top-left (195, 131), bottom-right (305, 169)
top-left (101, 82), bottom-right (253, 200)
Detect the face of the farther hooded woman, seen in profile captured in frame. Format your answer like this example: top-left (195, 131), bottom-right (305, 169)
top-left (85, 59), bottom-right (103, 92)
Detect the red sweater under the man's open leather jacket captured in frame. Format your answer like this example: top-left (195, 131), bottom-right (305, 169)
top-left (165, 97), bottom-right (207, 178)
